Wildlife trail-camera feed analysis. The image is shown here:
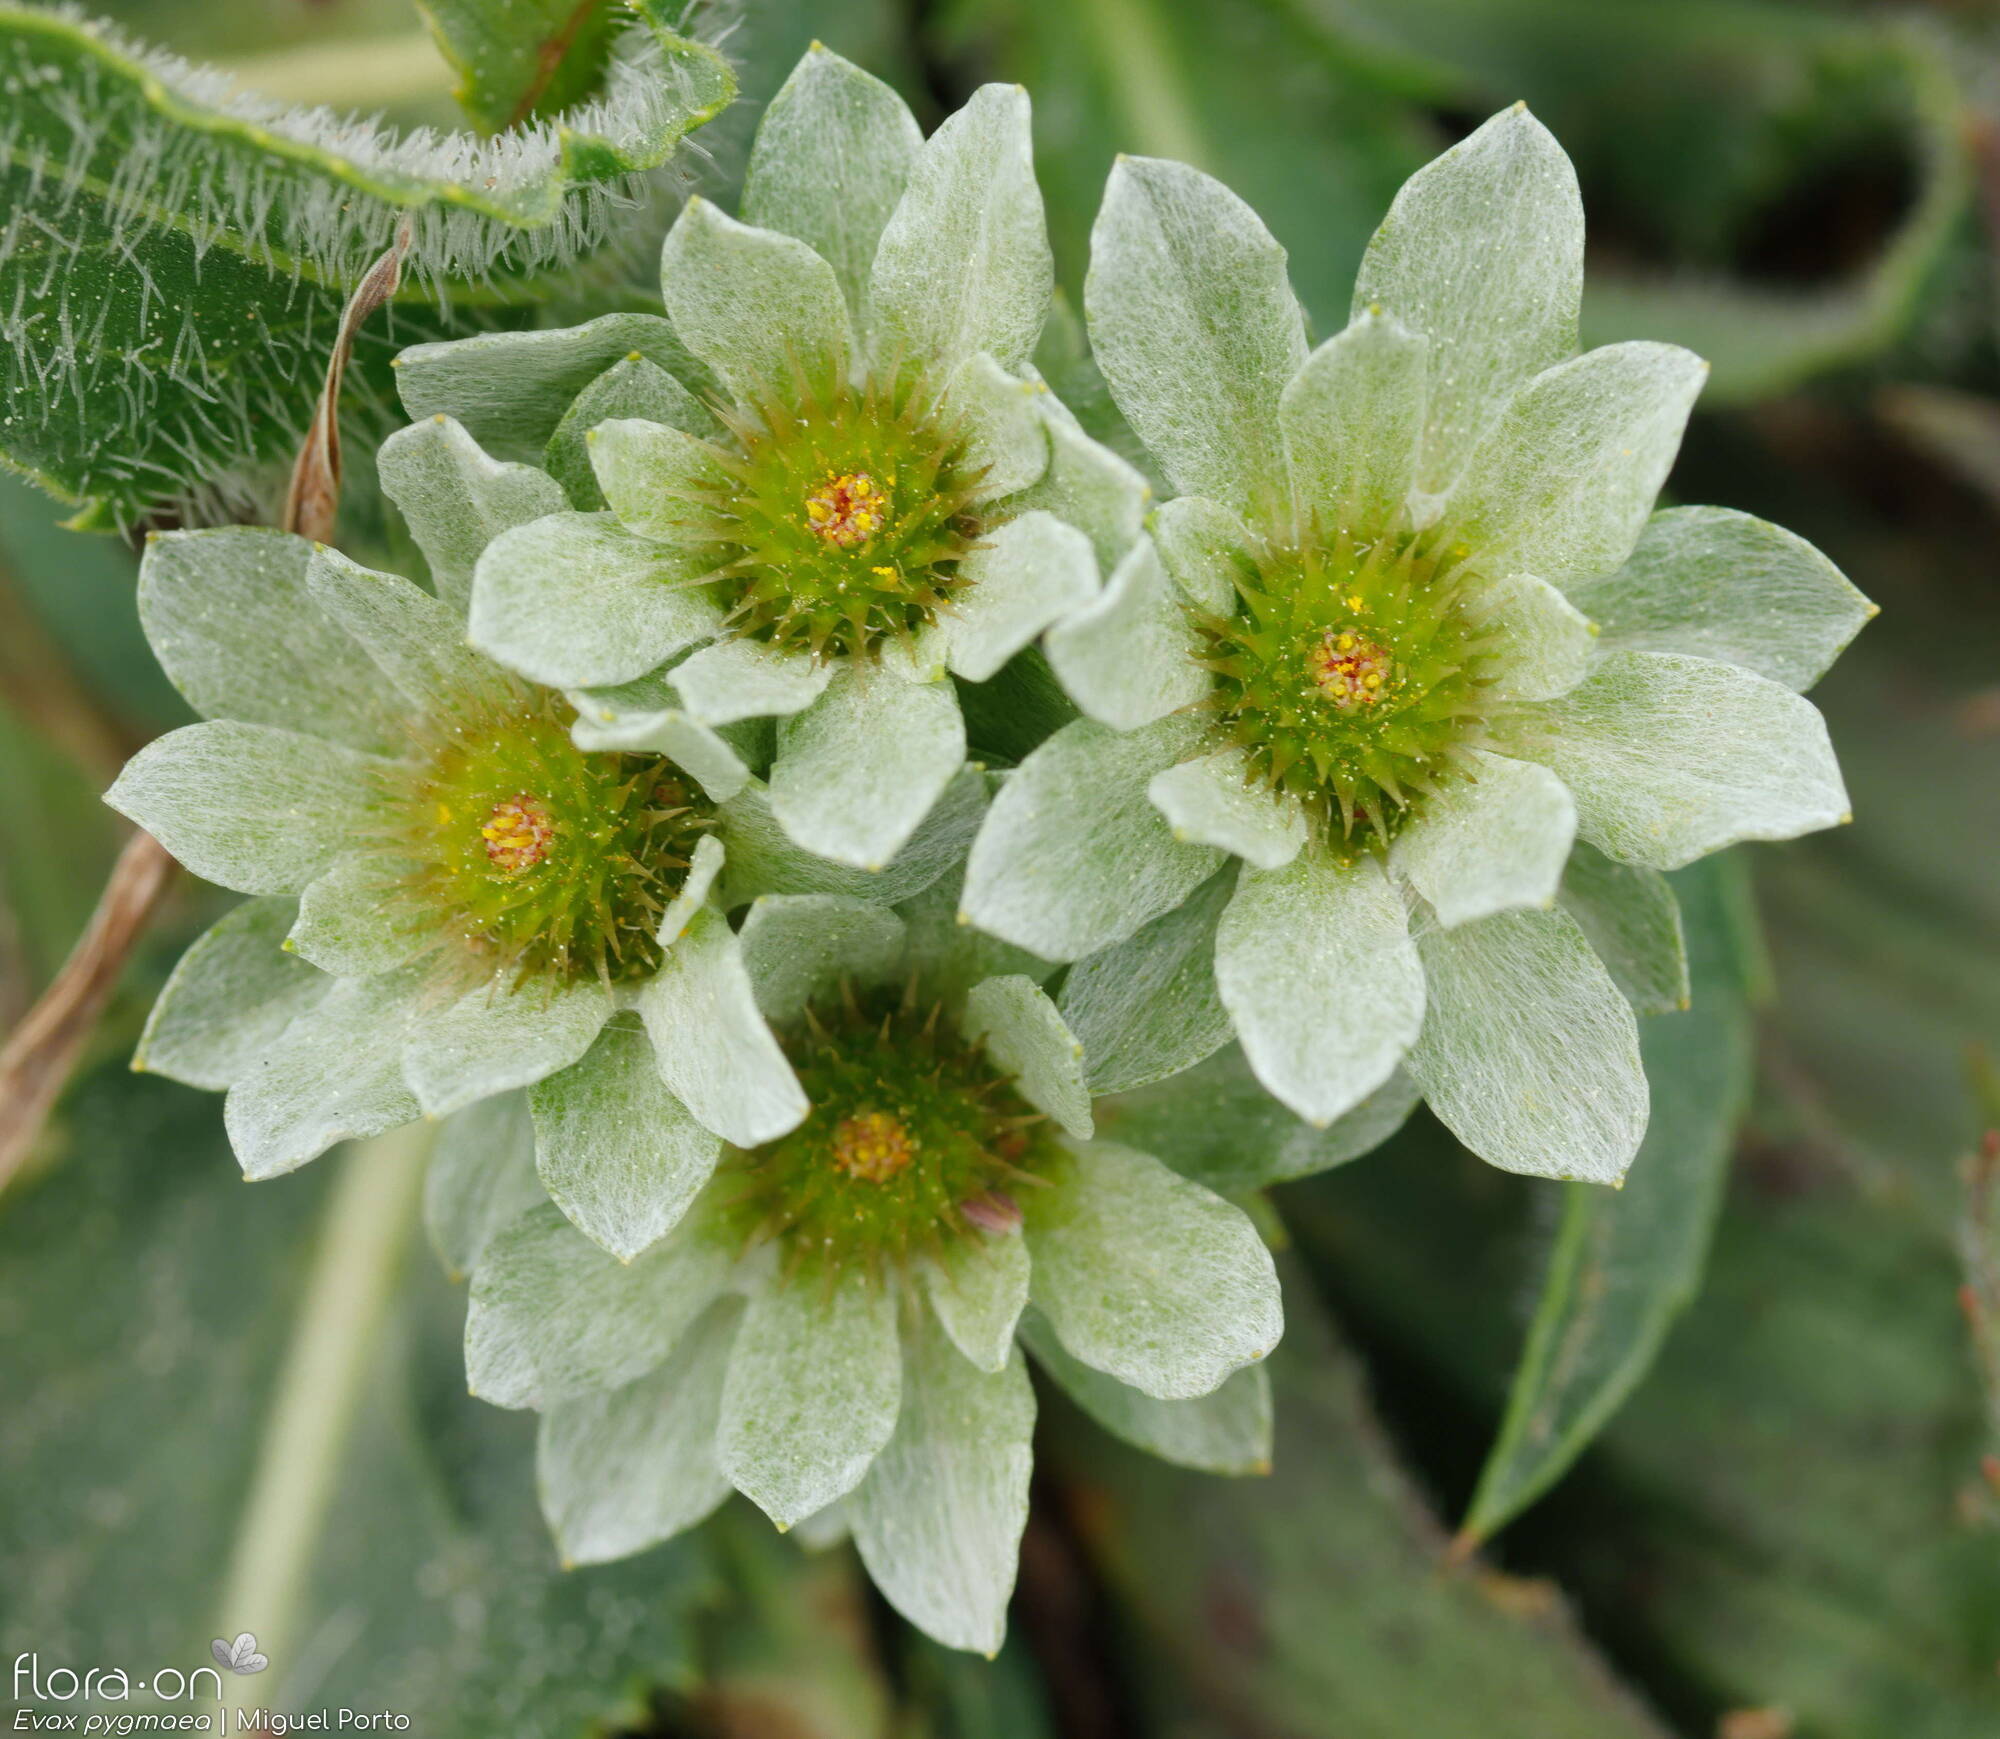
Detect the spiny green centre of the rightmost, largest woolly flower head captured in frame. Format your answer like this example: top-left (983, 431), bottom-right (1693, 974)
top-left (1194, 534), bottom-right (1498, 850)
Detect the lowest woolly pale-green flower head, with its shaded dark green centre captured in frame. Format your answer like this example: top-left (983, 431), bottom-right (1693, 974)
top-left (454, 881), bottom-right (1282, 1653)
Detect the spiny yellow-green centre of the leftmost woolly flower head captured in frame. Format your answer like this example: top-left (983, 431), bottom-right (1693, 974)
top-left (374, 684), bottom-right (712, 985)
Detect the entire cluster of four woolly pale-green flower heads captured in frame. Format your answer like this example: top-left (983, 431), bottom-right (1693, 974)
top-left (101, 48), bottom-right (1870, 1651)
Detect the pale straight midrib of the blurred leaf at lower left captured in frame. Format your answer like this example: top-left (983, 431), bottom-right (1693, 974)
top-left (216, 1123), bottom-right (436, 1705)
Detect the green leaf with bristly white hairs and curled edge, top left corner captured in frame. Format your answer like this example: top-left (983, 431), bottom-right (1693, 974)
top-left (0, 0), bottom-right (736, 528)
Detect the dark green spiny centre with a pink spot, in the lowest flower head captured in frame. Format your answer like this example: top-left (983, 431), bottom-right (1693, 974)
top-left (726, 993), bottom-right (1058, 1277)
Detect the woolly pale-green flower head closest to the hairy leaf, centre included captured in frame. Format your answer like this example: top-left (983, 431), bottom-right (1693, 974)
top-left (402, 48), bottom-right (1146, 870)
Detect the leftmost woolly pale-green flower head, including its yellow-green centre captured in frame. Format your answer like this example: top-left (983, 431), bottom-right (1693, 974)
top-left (108, 449), bottom-right (982, 1199)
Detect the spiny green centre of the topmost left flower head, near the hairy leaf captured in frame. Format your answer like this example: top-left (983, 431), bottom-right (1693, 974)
top-left (706, 382), bottom-right (980, 656)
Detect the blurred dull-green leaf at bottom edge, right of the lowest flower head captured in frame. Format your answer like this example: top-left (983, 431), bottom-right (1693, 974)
top-left (1040, 1265), bottom-right (1666, 1739)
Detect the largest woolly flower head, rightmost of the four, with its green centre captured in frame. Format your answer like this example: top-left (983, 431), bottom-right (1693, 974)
top-left (966, 108), bottom-right (1870, 1181)
